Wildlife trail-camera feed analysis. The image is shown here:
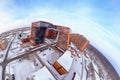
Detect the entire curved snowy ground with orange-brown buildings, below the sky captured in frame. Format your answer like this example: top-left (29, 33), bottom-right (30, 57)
top-left (0, 21), bottom-right (120, 80)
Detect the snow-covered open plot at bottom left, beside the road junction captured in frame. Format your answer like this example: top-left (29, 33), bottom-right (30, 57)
top-left (6, 60), bottom-right (41, 80)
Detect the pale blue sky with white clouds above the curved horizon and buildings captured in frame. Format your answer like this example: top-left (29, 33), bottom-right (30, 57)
top-left (0, 0), bottom-right (120, 74)
